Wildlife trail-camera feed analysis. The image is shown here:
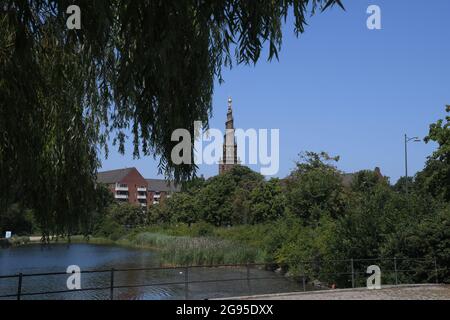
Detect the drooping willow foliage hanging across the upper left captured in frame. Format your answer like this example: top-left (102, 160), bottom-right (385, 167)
top-left (0, 0), bottom-right (342, 234)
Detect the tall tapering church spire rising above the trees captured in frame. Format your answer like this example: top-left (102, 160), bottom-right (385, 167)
top-left (219, 98), bottom-right (239, 174)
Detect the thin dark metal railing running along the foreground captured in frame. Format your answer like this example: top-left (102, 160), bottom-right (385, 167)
top-left (0, 257), bottom-right (447, 300)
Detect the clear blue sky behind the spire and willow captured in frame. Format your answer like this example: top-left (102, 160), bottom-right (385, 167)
top-left (102, 0), bottom-right (450, 181)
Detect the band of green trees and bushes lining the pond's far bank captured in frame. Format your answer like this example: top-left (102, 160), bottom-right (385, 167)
top-left (1, 107), bottom-right (450, 285)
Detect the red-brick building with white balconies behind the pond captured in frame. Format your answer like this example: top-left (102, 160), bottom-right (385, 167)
top-left (97, 168), bottom-right (181, 207)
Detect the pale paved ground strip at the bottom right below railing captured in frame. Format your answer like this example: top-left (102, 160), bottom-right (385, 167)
top-left (224, 284), bottom-right (450, 300)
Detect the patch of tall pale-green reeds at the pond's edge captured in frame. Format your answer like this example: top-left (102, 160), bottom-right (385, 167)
top-left (128, 232), bottom-right (262, 266)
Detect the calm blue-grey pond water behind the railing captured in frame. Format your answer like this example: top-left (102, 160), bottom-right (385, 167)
top-left (0, 244), bottom-right (302, 300)
